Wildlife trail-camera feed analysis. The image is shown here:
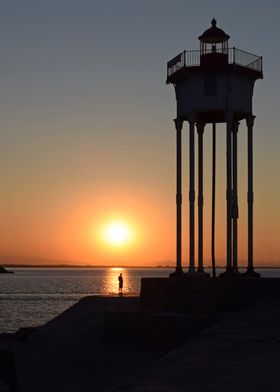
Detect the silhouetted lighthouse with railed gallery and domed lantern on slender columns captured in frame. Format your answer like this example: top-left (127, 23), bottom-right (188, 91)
top-left (166, 19), bottom-right (263, 277)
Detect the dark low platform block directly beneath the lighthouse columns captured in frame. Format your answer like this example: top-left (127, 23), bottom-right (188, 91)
top-left (140, 277), bottom-right (280, 314)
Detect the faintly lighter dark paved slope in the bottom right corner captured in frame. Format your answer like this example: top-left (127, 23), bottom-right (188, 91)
top-left (114, 300), bottom-right (280, 392)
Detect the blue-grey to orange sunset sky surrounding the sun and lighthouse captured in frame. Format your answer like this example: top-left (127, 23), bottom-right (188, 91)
top-left (0, 0), bottom-right (280, 266)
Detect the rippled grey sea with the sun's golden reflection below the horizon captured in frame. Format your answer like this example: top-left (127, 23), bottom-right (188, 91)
top-left (0, 268), bottom-right (280, 333)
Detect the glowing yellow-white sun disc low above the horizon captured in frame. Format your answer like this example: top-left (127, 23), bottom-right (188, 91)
top-left (104, 222), bottom-right (132, 246)
